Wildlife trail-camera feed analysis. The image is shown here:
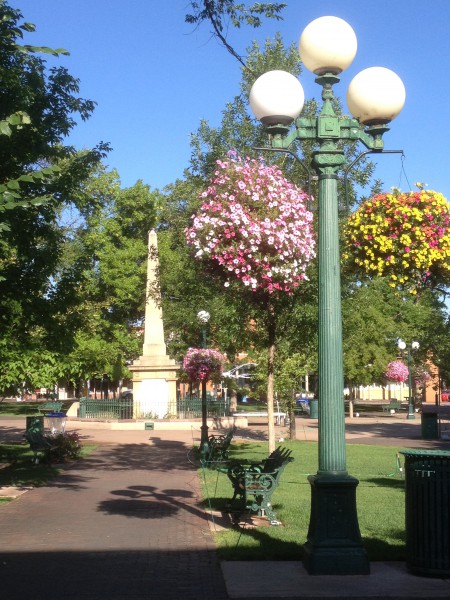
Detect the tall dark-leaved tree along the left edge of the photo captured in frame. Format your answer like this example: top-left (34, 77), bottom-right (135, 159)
top-left (0, 0), bottom-right (108, 396)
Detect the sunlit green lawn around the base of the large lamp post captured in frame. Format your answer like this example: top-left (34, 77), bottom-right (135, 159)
top-left (201, 441), bottom-right (405, 561)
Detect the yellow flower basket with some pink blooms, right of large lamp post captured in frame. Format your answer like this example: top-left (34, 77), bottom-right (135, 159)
top-left (344, 184), bottom-right (450, 294)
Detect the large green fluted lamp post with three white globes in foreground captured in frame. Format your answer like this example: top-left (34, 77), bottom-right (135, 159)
top-left (250, 17), bottom-right (405, 575)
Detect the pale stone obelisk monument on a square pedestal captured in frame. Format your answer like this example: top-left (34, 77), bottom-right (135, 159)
top-left (130, 230), bottom-right (179, 419)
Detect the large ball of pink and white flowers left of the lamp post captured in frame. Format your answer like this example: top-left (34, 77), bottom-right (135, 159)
top-left (185, 153), bottom-right (315, 294)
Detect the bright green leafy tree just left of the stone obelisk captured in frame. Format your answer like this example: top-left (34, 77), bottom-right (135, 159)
top-left (60, 169), bottom-right (161, 390)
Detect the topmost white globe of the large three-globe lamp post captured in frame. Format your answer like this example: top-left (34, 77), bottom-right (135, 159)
top-left (298, 17), bottom-right (358, 75)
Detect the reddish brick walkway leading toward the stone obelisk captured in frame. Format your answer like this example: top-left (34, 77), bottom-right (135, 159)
top-left (0, 432), bottom-right (227, 600)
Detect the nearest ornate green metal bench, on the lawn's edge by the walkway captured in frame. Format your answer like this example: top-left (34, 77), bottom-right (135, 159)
top-left (227, 446), bottom-right (294, 525)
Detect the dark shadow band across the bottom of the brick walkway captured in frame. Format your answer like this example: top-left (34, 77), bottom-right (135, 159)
top-left (0, 548), bottom-right (228, 600)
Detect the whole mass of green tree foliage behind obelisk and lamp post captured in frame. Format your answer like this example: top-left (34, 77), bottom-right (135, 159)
top-left (0, 0), bottom-right (450, 398)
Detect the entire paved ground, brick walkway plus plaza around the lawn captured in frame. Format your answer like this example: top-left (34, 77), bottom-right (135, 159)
top-left (0, 415), bottom-right (450, 600)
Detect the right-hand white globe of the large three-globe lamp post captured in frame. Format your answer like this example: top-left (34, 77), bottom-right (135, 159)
top-left (347, 67), bottom-right (406, 123)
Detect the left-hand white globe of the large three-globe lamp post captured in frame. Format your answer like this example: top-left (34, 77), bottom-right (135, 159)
top-left (249, 71), bottom-right (305, 125)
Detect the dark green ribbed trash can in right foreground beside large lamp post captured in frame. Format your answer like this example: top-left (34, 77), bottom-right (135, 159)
top-left (401, 450), bottom-right (450, 577)
